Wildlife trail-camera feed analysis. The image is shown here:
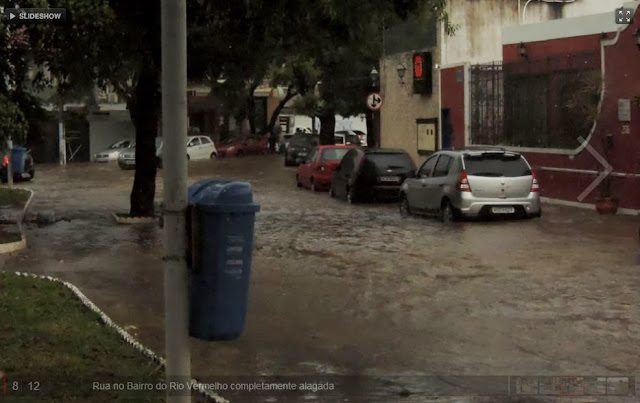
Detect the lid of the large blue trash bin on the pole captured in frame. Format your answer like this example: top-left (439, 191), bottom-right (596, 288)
top-left (188, 179), bottom-right (260, 213)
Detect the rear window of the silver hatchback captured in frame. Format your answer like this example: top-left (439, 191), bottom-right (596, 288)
top-left (464, 153), bottom-right (531, 177)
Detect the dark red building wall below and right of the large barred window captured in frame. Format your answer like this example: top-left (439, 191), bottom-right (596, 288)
top-left (503, 17), bottom-right (640, 209)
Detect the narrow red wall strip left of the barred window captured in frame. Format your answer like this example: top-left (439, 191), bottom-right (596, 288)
top-left (440, 66), bottom-right (467, 148)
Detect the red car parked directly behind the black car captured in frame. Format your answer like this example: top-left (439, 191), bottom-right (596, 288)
top-left (296, 144), bottom-right (357, 191)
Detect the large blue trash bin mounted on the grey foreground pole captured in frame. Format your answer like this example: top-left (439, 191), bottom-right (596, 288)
top-left (187, 179), bottom-right (260, 341)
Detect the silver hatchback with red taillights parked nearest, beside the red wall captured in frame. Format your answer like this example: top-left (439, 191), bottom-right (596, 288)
top-left (400, 149), bottom-right (542, 221)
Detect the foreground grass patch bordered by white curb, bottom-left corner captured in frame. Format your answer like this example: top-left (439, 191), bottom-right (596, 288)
top-left (0, 273), bottom-right (165, 402)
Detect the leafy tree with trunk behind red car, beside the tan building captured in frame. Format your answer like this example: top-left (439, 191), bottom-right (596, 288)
top-left (284, 0), bottom-right (454, 144)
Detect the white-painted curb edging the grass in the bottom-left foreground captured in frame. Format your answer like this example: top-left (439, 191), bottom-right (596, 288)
top-left (0, 270), bottom-right (229, 403)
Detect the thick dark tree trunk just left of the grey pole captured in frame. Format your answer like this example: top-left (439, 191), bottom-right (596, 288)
top-left (129, 64), bottom-right (161, 217)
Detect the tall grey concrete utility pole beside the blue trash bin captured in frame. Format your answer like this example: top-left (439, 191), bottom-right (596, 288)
top-left (162, 0), bottom-right (191, 403)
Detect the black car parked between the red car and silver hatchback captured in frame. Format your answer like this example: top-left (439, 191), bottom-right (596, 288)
top-left (330, 148), bottom-right (416, 203)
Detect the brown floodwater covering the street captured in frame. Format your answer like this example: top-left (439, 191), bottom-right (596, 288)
top-left (4, 156), bottom-right (640, 402)
